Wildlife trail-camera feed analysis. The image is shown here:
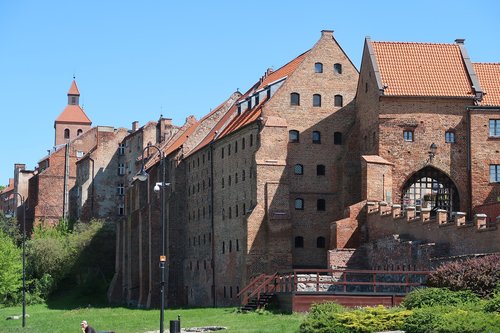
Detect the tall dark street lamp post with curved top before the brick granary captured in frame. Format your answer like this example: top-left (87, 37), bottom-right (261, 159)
top-left (134, 145), bottom-right (170, 333)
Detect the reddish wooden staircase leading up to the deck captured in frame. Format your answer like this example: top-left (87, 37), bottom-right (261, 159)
top-left (237, 273), bottom-right (278, 311)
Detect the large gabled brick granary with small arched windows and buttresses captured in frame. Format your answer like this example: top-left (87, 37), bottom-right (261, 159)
top-left (109, 31), bottom-right (360, 307)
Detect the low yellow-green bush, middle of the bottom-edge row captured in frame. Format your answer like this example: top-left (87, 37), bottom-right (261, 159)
top-left (337, 305), bottom-right (411, 333)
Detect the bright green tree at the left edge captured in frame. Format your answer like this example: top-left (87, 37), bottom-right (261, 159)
top-left (0, 230), bottom-right (23, 304)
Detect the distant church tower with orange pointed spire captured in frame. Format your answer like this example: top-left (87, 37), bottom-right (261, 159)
top-left (54, 78), bottom-right (92, 146)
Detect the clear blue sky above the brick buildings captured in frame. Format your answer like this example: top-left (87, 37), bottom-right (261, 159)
top-left (0, 0), bottom-right (500, 185)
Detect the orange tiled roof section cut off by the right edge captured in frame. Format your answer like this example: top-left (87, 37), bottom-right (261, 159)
top-left (473, 63), bottom-right (500, 106)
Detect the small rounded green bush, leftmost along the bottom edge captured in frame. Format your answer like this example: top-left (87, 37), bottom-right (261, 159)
top-left (299, 302), bottom-right (350, 333)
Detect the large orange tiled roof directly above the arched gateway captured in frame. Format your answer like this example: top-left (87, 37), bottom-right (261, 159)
top-left (372, 42), bottom-right (474, 98)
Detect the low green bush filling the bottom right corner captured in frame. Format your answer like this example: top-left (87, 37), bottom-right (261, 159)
top-left (402, 306), bottom-right (500, 333)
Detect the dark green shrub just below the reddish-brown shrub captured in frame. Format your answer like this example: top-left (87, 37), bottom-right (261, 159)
top-left (401, 288), bottom-right (480, 309)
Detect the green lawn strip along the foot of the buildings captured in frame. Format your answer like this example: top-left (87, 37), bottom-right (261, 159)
top-left (0, 295), bottom-right (304, 333)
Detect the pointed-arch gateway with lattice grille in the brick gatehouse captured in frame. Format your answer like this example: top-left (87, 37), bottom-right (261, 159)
top-left (401, 166), bottom-right (460, 216)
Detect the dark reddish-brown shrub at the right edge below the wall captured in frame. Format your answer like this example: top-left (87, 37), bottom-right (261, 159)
top-left (428, 254), bottom-right (500, 297)
